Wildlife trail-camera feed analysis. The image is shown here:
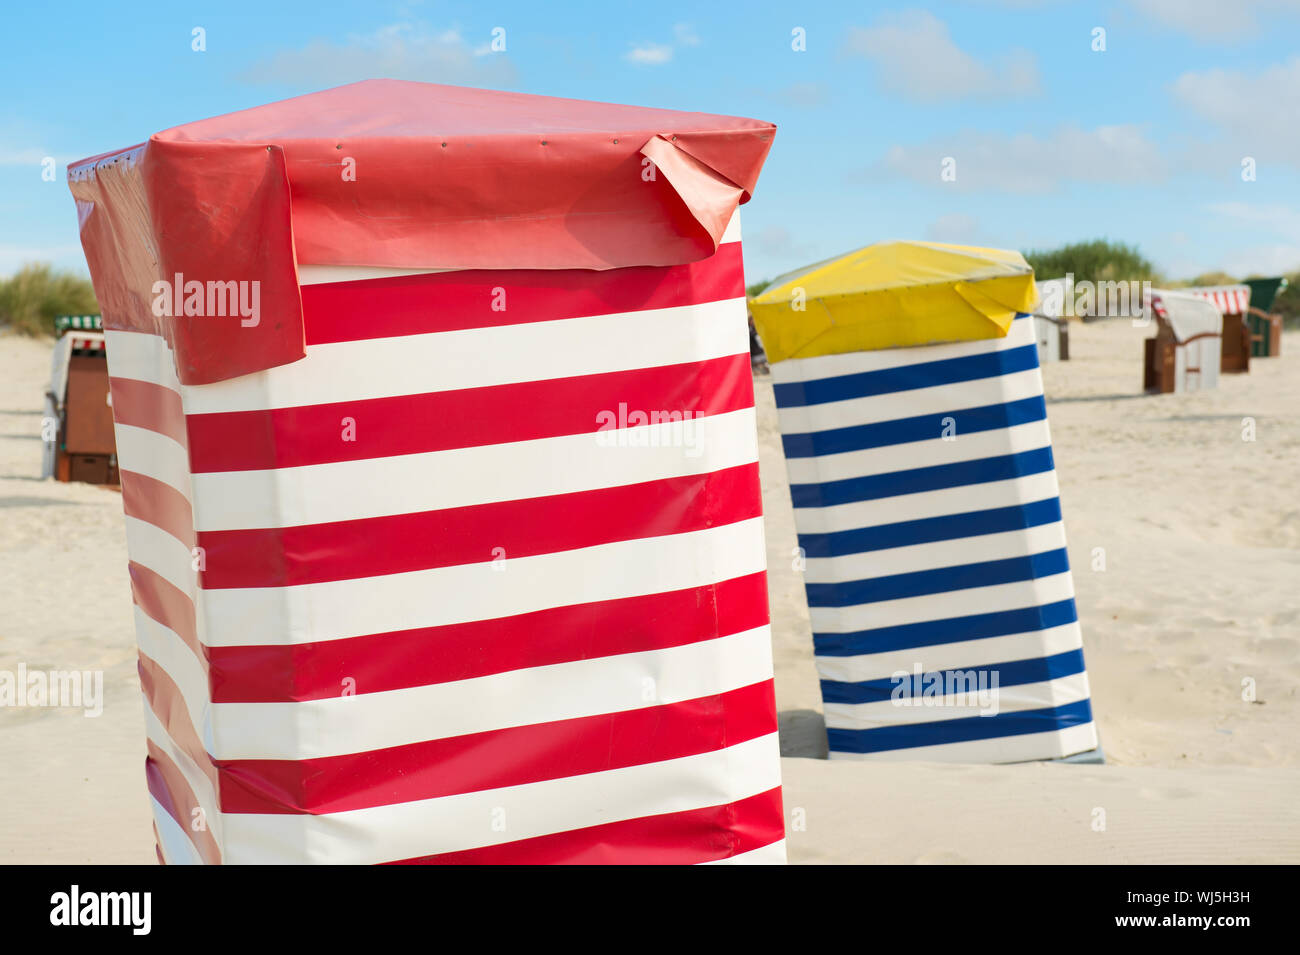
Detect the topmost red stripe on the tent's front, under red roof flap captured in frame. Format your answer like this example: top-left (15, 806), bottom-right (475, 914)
top-left (302, 242), bottom-right (745, 344)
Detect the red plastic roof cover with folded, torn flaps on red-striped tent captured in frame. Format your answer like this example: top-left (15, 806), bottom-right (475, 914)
top-left (69, 79), bottom-right (775, 385)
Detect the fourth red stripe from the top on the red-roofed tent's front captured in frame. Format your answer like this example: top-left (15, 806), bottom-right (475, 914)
top-left (207, 572), bottom-right (768, 703)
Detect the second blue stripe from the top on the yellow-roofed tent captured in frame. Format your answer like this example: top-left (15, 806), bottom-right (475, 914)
top-left (781, 395), bottom-right (1048, 457)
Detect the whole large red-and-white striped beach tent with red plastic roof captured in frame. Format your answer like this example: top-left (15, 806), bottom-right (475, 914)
top-left (69, 81), bottom-right (784, 863)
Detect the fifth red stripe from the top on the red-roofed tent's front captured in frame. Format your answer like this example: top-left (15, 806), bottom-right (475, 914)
top-left (218, 680), bottom-right (776, 815)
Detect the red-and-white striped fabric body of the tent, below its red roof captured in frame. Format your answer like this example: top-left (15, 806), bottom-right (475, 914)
top-left (108, 222), bottom-right (784, 864)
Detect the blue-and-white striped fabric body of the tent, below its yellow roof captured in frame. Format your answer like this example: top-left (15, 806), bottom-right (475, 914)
top-left (772, 314), bottom-right (1097, 763)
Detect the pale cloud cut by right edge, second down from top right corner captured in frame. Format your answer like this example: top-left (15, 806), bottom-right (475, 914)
top-left (1173, 56), bottom-right (1300, 166)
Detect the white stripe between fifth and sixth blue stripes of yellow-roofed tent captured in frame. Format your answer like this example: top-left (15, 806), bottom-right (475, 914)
top-left (809, 570), bottom-right (1074, 633)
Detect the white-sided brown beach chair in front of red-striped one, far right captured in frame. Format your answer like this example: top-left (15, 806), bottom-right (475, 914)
top-left (1143, 290), bottom-right (1225, 395)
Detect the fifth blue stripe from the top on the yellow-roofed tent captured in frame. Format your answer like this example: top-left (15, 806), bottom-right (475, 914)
top-left (805, 547), bottom-right (1070, 607)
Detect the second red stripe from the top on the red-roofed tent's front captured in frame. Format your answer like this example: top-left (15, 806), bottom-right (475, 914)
top-left (187, 355), bottom-right (754, 474)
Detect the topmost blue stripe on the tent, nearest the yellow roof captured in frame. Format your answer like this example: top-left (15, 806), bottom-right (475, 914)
top-left (772, 343), bottom-right (1039, 408)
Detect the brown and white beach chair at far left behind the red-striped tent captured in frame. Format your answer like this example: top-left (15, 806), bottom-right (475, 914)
top-left (42, 314), bottom-right (118, 486)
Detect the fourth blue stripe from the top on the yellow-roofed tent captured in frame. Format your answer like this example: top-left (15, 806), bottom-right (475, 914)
top-left (800, 498), bottom-right (1061, 557)
